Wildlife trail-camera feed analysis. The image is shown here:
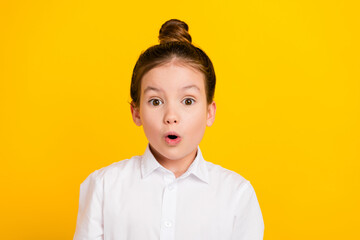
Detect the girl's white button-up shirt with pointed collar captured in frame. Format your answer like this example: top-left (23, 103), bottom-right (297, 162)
top-left (74, 144), bottom-right (264, 240)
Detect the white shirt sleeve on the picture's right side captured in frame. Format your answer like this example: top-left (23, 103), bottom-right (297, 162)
top-left (231, 182), bottom-right (264, 240)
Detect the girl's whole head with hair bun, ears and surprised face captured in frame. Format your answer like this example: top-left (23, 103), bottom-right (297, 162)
top-left (131, 19), bottom-right (216, 164)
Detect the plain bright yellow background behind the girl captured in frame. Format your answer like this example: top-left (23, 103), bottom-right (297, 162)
top-left (0, 0), bottom-right (360, 240)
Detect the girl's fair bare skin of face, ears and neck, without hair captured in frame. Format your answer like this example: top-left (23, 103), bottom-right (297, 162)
top-left (131, 59), bottom-right (216, 177)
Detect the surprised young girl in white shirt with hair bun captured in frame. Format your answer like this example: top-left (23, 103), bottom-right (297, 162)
top-left (74, 19), bottom-right (264, 240)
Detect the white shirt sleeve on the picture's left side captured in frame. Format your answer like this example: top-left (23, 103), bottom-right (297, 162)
top-left (73, 170), bottom-right (104, 240)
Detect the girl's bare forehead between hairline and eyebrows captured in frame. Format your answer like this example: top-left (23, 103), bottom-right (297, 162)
top-left (141, 62), bottom-right (205, 91)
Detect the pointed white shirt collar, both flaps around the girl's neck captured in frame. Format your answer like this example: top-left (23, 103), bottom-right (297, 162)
top-left (141, 143), bottom-right (209, 183)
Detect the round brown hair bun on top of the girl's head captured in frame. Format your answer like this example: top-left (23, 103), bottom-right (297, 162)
top-left (159, 19), bottom-right (191, 44)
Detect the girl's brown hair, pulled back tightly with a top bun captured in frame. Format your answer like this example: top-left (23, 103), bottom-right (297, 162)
top-left (130, 19), bottom-right (216, 107)
